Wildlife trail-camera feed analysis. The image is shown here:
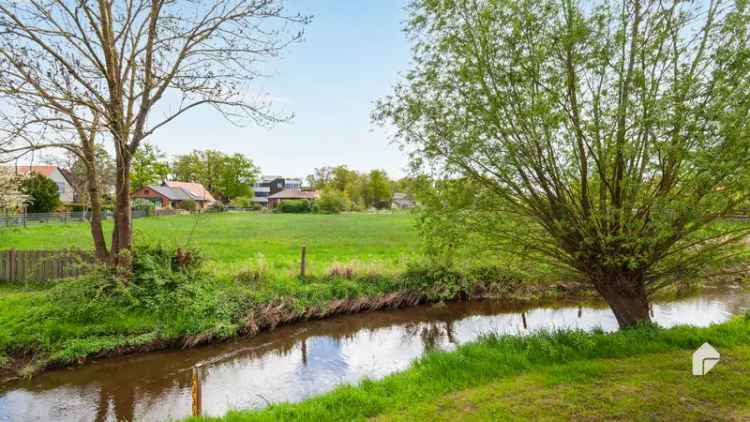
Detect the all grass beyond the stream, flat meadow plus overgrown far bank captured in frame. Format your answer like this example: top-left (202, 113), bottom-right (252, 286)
top-left (0, 213), bottom-right (540, 376)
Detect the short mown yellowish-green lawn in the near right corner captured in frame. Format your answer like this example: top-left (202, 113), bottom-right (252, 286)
top-left (374, 347), bottom-right (750, 422)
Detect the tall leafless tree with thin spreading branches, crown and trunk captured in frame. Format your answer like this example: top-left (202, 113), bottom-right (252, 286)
top-left (0, 0), bottom-right (309, 263)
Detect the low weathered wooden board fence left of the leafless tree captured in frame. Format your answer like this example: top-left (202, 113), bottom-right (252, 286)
top-left (0, 249), bottom-right (94, 283)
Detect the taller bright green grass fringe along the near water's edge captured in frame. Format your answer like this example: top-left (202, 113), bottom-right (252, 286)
top-left (191, 313), bottom-right (750, 422)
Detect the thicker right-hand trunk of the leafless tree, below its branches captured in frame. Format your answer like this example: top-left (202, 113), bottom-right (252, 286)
top-left (112, 156), bottom-right (133, 266)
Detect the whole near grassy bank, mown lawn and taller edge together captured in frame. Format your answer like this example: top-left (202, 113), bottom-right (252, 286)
top-left (189, 316), bottom-right (750, 422)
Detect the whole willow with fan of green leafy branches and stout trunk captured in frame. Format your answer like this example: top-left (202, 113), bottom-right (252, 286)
top-left (375, 0), bottom-right (750, 327)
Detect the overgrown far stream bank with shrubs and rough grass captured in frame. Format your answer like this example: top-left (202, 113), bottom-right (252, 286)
top-left (0, 246), bottom-right (544, 375)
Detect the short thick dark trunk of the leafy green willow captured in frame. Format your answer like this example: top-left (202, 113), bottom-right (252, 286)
top-left (594, 275), bottom-right (651, 328)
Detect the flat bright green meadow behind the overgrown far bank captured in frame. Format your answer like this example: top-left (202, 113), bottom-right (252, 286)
top-left (0, 213), bottom-right (418, 273)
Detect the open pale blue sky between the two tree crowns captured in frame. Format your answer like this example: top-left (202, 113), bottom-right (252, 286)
top-left (150, 0), bottom-right (410, 177)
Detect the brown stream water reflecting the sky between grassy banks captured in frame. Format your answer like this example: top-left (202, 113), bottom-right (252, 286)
top-left (0, 289), bottom-right (750, 422)
